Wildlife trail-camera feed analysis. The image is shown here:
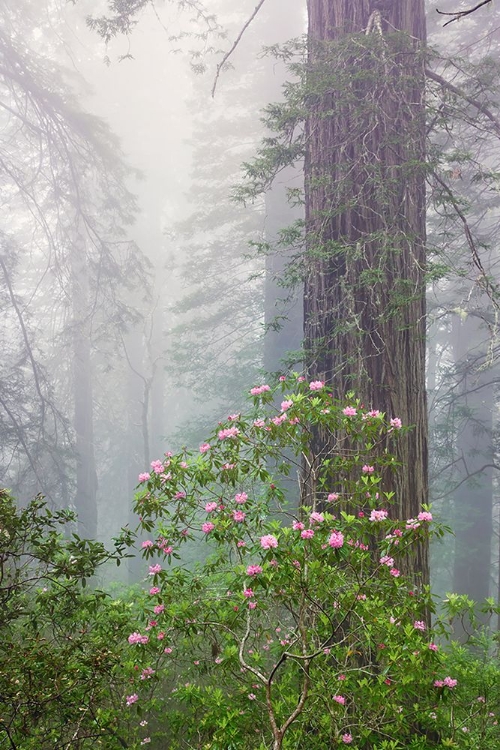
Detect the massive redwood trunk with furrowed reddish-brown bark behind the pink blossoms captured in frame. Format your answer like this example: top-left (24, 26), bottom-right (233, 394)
top-left (304, 0), bottom-right (428, 582)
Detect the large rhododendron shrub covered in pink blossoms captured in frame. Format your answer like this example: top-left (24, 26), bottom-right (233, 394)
top-left (128, 377), bottom-right (494, 750)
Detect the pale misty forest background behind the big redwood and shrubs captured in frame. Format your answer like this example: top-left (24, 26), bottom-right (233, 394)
top-left (0, 0), bottom-right (500, 612)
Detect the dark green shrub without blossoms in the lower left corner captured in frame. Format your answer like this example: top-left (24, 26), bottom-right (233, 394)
top-left (0, 490), bottom-right (142, 750)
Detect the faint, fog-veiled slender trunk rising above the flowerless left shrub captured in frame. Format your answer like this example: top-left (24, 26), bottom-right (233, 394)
top-left (70, 242), bottom-right (97, 539)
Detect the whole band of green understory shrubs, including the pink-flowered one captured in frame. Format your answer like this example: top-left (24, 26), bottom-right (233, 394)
top-left (0, 382), bottom-right (500, 750)
